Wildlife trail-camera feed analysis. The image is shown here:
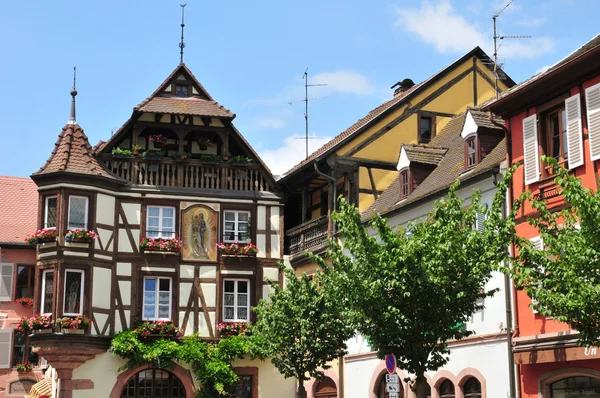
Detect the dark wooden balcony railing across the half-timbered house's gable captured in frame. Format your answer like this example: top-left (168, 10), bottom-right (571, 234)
top-left (103, 155), bottom-right (273, 192)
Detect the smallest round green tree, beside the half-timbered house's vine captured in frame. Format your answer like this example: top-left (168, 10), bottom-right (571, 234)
top-left (252, 266), bottom-right (354, 398)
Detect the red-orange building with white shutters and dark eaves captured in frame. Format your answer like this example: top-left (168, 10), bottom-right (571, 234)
top-left (484, 35), bottom-right (600, 398)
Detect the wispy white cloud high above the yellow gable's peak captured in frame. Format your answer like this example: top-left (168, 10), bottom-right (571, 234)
top-left (394, 0), bottom-right (554, 59)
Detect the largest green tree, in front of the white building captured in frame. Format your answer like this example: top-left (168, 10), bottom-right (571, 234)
top-left (319, 168), bottom-right (518, 398)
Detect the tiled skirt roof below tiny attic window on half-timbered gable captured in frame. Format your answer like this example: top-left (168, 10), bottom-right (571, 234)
top-left (134, 97), bottom-right (235, 119)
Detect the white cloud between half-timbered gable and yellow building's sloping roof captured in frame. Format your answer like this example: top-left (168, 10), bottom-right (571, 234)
top-left (258, 134), bottom-right (332, 175)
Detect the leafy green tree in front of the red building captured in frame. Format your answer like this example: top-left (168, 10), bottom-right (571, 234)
top-left (514, 157), bottom-right (600, 345)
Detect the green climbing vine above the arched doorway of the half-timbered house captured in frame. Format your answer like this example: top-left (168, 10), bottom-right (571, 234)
top-left (110, 329), bottom-right (254, 398)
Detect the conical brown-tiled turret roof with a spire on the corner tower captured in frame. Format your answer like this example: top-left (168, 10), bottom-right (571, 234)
top-left (33, 123), bottom-right (115, 180)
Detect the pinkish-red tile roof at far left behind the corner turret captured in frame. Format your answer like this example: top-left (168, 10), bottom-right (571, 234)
top-left (0, 176), bottom-right (38, 243)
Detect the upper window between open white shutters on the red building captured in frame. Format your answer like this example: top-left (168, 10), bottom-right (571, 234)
top-left (542, 105), bottom-right (568, 175)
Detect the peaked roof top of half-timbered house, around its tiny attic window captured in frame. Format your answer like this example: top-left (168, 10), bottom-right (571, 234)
top-left (133, 62), bottom-right (235, 119)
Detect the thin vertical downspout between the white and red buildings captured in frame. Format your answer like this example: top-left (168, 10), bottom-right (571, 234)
top-left (489, 111), bottom-right (520, 398)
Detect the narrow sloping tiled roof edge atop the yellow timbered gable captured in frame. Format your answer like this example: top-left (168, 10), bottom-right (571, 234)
top-left (280, 47), bottom-right (515, 181)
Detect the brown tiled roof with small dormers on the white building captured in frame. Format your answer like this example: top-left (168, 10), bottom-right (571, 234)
top-left (362, 113), bottom-right (506, 221)
